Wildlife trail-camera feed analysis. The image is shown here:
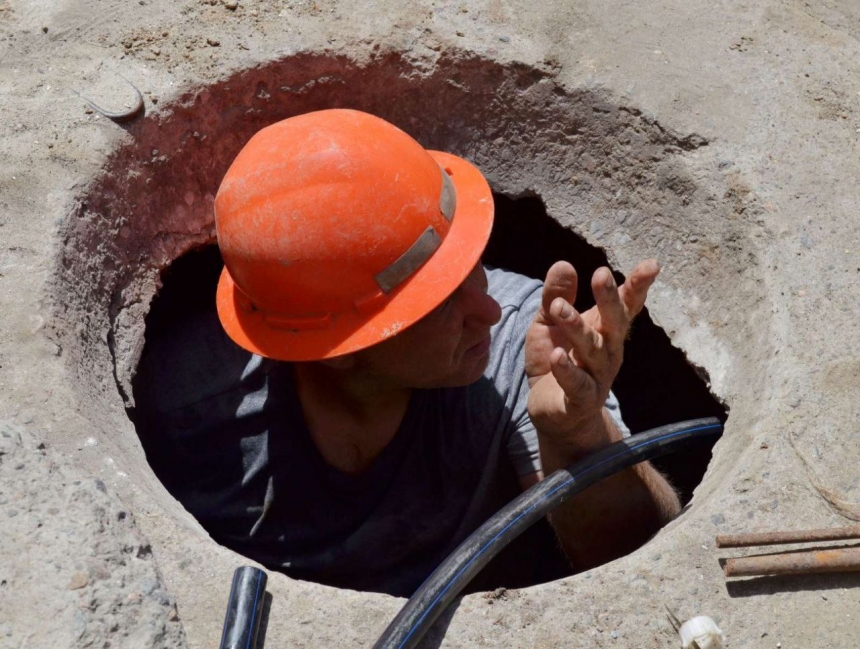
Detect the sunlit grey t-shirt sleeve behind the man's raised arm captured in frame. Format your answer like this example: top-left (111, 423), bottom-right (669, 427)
top-left (494, 273), bottom-right (630, 477)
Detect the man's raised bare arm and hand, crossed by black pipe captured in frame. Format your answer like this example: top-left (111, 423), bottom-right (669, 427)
top-left (521, 262), bottom-right (680, 570)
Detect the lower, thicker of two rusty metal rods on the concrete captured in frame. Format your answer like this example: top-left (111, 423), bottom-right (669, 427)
top-left (724, 548), bottom-right (860, 577)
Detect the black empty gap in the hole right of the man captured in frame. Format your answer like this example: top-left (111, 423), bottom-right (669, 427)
top-left (483, 194), bottom-right (727, 504)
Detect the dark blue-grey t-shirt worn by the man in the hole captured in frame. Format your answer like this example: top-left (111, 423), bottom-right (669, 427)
top-left (136, 270), bottom-right (623, 596)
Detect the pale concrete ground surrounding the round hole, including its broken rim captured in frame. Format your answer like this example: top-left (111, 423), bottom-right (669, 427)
top-left (0, 0), bottom-right (860, 648)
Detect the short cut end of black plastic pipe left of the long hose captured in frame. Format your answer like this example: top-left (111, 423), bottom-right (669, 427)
top-left (221, 566), bottom-right (267, 649)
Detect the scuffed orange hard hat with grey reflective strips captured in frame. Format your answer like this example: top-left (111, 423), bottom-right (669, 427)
top-left (215, 109), bottom-right (493, 361)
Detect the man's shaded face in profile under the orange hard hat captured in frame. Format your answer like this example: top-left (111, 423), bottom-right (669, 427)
top-left (356, 263), bottom-right (502, 388)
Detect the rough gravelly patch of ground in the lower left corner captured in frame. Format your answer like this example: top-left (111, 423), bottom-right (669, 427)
top-left (0, 422), bottom-right (186, 649)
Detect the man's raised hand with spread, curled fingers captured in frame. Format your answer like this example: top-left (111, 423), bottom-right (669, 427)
top-left (525, 259), bottom-right (660, 452)
